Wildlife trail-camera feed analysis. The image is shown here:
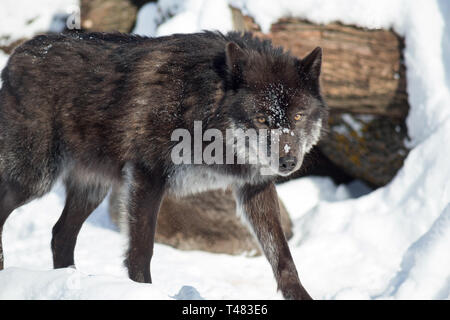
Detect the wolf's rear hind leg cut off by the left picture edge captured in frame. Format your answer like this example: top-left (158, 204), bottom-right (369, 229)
top-left (0, 177), bottom-right (36, 270)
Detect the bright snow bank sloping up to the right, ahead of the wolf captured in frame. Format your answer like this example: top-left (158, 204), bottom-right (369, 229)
top-left (288, 121), bottom-right (450, 299)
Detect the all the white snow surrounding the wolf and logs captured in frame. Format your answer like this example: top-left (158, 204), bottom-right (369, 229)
top-left (0, 0), bottom-right (450, 299)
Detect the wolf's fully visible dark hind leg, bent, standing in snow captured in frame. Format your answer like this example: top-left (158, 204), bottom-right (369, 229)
top-left (51, 178), bottom-right (109, 268)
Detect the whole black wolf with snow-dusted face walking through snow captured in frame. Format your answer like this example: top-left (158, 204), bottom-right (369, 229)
top-left (0, 32), bottom-right (327, 299)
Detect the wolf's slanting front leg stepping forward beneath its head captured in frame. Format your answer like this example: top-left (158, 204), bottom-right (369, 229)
top-left (234, 183), bottom-right (311, 300)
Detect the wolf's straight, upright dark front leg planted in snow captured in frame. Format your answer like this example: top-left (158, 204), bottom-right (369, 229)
top-left (125, 166), bottom-right (165, 283)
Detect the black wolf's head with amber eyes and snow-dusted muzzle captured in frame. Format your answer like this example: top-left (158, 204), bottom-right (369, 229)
top-left (224, 38), bottom-right (328, 176)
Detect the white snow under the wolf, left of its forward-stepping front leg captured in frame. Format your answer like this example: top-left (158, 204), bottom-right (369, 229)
top-left (0, 185), bottom-right (281, 299)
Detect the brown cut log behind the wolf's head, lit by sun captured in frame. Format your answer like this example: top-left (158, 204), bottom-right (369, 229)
top-left (232, 8), bottom-right (409, 118)
